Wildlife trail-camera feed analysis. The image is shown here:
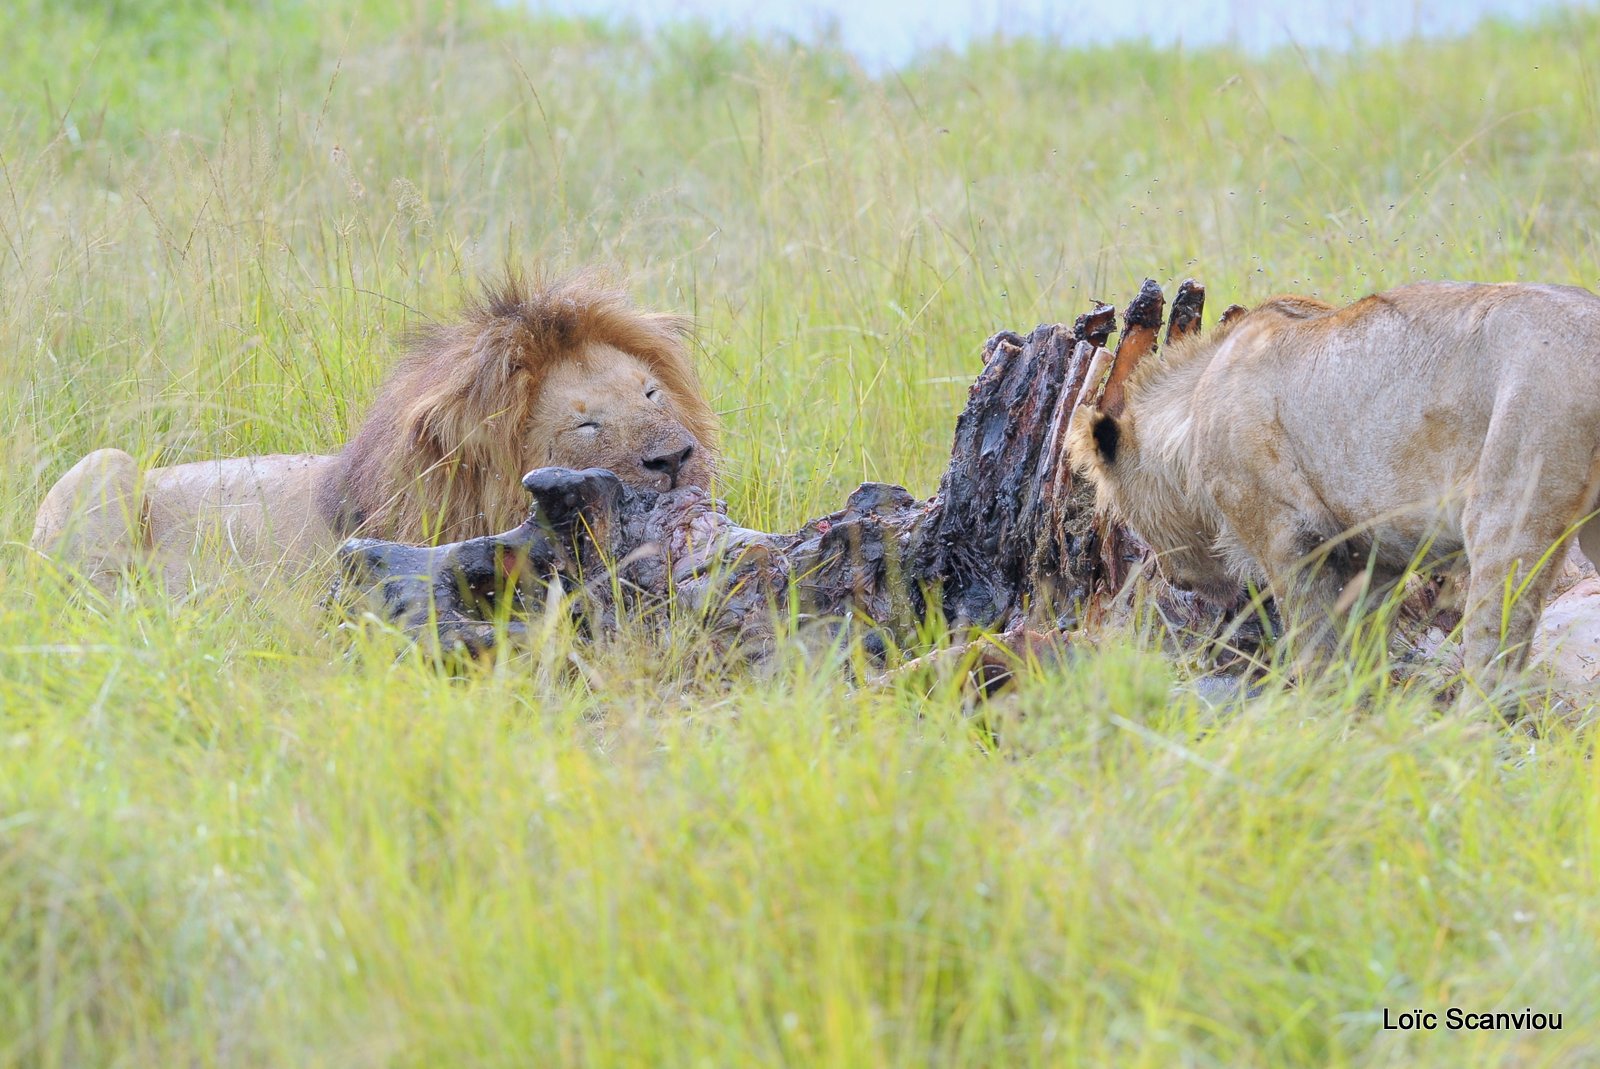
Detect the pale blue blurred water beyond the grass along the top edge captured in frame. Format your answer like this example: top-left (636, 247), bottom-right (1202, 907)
top-left (510, 0), bottom-right (1595, 70)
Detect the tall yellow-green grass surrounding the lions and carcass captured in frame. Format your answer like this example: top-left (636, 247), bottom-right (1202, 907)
top-left (0, 0), bottom-right (1600, 1067)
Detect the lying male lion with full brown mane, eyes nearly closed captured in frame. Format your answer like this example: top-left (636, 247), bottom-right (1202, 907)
top-left (32, 275), bottom-right (717, 594)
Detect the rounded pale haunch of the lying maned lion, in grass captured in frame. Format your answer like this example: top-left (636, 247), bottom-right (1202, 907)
top-left (29, 450), bottom-right (147, 592)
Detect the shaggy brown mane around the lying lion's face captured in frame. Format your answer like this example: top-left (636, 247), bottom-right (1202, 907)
top-left (322, 272), bottom-right (717, 541)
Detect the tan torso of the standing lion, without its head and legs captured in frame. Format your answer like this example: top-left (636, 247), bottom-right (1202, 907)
top-left (1194, 282), bottom-right (1600, 537)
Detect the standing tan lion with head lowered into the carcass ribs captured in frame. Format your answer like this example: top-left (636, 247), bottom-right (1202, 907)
top-left (1069, 282), bottom-right (1600, 682)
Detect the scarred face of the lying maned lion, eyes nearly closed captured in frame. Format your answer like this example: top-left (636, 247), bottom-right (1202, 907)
top-left (526, 344), bottom-right (710, 491)
